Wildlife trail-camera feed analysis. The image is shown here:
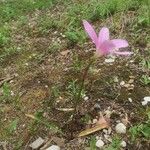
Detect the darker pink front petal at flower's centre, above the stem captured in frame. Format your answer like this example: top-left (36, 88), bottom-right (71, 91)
top-left (97, 41), bottom-right (115, 55)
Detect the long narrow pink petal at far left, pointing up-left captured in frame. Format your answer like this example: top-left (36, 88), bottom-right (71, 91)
top-left (83, 20), bottom-right (97, 45)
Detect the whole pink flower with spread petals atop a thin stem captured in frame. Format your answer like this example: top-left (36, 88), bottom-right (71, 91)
top-left (83, 20), bottom-right (132, 55)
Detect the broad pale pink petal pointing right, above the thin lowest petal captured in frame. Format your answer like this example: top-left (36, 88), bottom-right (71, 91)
top-left (111, 39), bottom-right (129, 48)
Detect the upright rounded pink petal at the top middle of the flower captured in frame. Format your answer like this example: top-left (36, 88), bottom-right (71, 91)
top-left (98, 27), bottom-right (109, 47)
